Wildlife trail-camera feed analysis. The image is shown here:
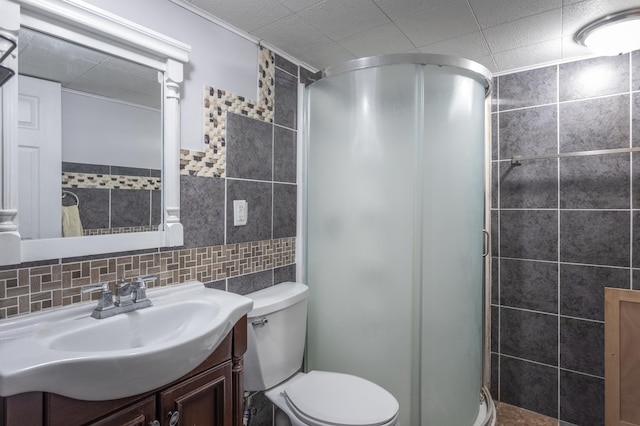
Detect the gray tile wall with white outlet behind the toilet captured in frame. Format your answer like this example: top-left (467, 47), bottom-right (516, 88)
top-left (180, 55), bottom-right (298, 294)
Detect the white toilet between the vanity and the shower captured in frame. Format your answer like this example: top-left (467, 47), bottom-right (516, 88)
top-left (244, 282), bottom-right (399, 426)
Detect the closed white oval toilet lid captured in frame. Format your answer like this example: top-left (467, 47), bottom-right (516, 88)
top-left (284, 371), bottom-right (399, 426)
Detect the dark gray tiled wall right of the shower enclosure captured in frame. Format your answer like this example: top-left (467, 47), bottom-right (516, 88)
top-left (491, 52), bottom-right (640, 426)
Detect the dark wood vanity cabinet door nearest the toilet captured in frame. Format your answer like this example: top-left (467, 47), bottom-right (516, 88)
top-left (160, 362), bottom-right (233, 426)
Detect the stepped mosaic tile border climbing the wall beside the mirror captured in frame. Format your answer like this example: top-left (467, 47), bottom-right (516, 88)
top-left (180, 47), bottom-right (275, 177)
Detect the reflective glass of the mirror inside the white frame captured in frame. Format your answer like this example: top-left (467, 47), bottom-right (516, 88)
top-left (18, 27), bottom-right (163, 239)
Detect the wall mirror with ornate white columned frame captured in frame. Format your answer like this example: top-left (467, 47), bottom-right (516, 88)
top-left (0, 0), bottom-right (190, 265)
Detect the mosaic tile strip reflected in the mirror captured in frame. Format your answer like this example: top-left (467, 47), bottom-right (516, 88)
top-left (62, 172), bottom-right (162, 191)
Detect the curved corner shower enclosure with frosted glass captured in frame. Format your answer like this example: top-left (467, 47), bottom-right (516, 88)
top-left (304, 54), bottom-right (493, 426)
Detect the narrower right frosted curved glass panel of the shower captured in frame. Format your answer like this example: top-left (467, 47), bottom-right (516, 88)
top-left (421, 65), bottom-right (485, 425)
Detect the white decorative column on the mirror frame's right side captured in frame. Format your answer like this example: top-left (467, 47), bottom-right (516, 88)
top-left (162, 59), bottom-right (183, 246)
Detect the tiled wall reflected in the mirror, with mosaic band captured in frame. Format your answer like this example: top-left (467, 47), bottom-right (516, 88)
top-left (62, 162), bottom-right (162, 235)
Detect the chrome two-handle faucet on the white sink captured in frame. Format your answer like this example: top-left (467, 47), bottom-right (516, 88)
top-left (82, 275), bottom-right (158, 319)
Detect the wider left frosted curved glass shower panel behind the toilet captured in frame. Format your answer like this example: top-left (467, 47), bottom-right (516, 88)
top-left (307, 64), bottom-right (420, 425)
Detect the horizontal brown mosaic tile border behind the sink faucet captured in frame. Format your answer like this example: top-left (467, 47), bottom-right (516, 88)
top-left (0, 237), bottom-right (296, 319)
